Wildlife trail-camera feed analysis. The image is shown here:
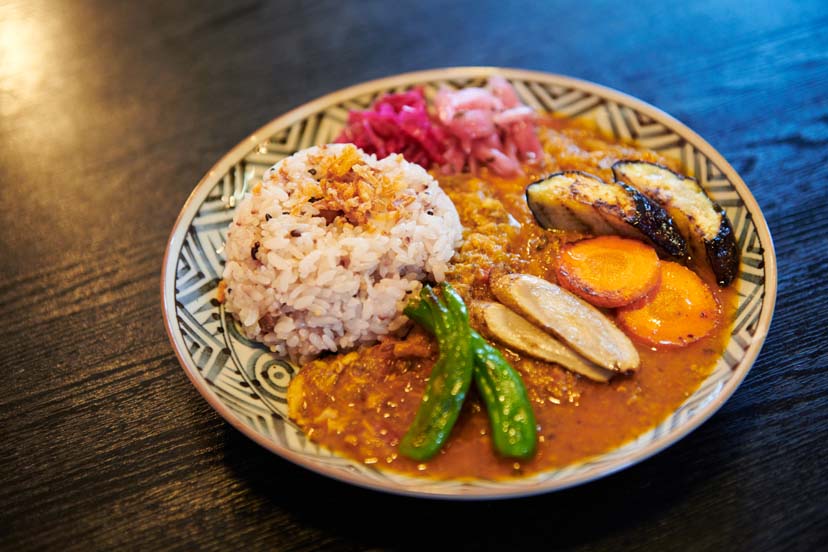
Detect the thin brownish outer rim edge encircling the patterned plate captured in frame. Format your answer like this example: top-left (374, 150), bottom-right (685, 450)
top-left (160, 67), bottom-right (777, 500)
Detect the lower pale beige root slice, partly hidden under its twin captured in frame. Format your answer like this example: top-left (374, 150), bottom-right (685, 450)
top-left (473, 301), bottom-right (615, 383)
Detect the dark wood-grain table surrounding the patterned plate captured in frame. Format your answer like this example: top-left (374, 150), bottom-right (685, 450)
top-left (0, 0), bottom-right (828, 550)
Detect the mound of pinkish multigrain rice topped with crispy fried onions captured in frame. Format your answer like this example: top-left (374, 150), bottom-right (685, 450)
top-left (223, 144), bottom-right (462, 362)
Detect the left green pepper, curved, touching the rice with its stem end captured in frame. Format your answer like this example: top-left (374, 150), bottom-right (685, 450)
top-left (400, 286), bottom-right (473, 461)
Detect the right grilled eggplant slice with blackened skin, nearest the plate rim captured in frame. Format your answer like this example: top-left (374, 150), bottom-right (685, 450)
top-left (612, 161), bottom-right (739, 287)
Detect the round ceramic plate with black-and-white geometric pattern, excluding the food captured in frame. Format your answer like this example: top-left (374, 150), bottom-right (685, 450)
top-left (162, 67), bottom-right (776, 499)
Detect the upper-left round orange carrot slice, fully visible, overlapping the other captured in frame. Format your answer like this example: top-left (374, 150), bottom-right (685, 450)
top-left (557, 236), bottom-right (661, 308)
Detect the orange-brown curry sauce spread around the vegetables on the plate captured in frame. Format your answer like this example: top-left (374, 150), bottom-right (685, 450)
top-left (290, 117), bottom-right (737, 479)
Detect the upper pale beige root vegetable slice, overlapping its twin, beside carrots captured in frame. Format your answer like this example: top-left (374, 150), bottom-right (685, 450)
top-left (491, 274), bottom-right (640, 373)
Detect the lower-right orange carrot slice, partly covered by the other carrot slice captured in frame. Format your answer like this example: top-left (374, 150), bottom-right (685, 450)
top-left (618, 261), bottom-right (721, 347)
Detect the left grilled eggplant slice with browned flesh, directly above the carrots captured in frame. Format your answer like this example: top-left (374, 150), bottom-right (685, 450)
top-left (526, 171), bottom-right (687, 257)
